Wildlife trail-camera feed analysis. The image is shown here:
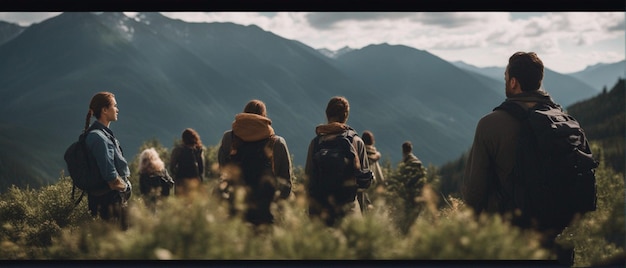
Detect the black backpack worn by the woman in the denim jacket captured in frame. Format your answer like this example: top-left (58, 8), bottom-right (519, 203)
top-left (63, 125), bottom-right (115, 204)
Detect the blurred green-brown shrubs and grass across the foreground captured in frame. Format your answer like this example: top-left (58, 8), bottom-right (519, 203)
top-left (0, 141), bottom-right (626, 266)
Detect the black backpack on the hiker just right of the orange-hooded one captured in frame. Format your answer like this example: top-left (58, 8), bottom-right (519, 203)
top-left (309, 129), bottom-right (373, 204)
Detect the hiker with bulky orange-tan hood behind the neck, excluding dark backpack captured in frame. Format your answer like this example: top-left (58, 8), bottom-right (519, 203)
top-left (218, 100), bottom-right (292, 224)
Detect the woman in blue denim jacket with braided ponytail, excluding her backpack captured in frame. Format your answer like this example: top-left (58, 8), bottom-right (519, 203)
top-left (85, 92), bottom-right (132, 230)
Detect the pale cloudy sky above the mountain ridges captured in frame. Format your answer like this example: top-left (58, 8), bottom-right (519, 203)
top-left (0, 11), bottom-right (626, 73)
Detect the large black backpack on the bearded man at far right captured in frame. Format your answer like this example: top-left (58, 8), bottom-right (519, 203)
top-left (494, 101), bottom-right (598, 230)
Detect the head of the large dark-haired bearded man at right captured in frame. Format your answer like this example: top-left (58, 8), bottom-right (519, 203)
top-left (504, 52), bottom-right (543, 97)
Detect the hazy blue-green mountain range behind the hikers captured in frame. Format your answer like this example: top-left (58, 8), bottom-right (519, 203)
top-left (0, 12), bottom-right (617, 191)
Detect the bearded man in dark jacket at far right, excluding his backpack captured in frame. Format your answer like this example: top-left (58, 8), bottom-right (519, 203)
top-left (461, 52), bottom-right (573, 265)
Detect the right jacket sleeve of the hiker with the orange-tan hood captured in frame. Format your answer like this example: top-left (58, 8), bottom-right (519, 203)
top-left (273, 137), bottom-right (292, 198)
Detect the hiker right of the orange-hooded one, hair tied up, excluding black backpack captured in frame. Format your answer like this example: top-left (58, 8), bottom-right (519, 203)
top-left (304, 96), bottom-right (371, 226)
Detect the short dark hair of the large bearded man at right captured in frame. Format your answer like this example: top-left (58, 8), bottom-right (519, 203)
top-left (507, 52), bottom-right (543, 91)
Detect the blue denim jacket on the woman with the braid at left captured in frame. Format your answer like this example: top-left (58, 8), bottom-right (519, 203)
top-left (85, 121), bottom-right (130, 186)
